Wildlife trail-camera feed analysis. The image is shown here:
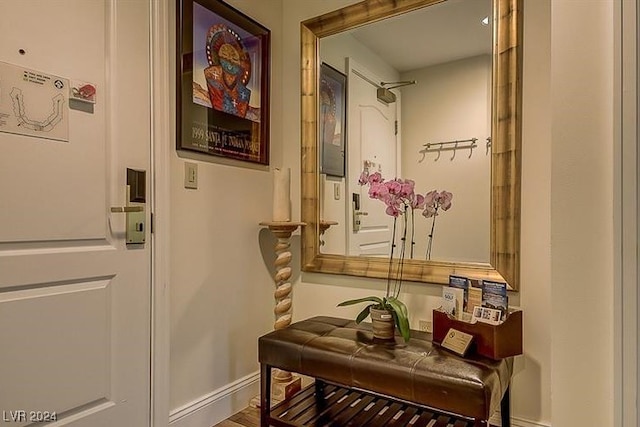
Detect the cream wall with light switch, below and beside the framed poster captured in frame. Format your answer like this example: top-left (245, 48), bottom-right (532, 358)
top-left (170, 0), bottom-right (284, 425)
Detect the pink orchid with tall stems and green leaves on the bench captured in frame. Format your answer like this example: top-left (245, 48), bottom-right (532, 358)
top-left (338, 168), bottom-right (453, 341)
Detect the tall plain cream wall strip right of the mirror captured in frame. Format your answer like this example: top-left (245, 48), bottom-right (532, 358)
top-left (551, 0), bottom-right (614, 426)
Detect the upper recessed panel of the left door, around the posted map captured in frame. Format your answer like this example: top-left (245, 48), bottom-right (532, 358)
top-left (0, 0), bottom-right (108, 242)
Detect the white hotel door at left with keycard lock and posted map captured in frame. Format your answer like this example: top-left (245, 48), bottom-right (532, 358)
top-left (0, 0), bottom-right (151, 427)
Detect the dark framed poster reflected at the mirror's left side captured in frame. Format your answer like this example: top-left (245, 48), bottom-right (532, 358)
top-left (318, 62), bottom-right (347, 177)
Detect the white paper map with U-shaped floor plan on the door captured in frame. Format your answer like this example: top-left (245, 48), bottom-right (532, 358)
top-left (0, 62), bottom-right (69, 142)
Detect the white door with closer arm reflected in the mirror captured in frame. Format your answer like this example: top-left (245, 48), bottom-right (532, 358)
top-left (347, 60), bottom-right (398, 256)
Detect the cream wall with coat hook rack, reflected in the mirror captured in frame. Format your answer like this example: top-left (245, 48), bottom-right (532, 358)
top-left (400, 55), bottom-right (491, 262)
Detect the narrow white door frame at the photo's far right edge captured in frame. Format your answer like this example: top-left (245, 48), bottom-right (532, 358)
top-left (613, 0), bottom-right (640, 427)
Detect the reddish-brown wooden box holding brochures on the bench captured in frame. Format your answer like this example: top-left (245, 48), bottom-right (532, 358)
top-left (433, 310), bottom-right (522, 360)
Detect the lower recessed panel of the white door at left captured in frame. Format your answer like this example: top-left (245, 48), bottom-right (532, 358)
top-left (0, 280), bottom-right (112, 412)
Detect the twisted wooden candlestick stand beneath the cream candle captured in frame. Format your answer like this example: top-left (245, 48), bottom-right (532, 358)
top-left (260, 221), bottom-right (306, 382)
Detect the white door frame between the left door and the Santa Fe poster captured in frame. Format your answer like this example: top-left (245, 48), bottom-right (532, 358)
top-left (148, 0), bottom-right (175, 427)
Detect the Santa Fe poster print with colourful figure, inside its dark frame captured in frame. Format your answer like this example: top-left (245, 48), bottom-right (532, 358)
top-left (191, 2), bottom-right (263, 160)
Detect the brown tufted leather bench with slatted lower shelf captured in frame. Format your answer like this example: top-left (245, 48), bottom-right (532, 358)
top-left (258, 316), bottom-right (513, 427)
